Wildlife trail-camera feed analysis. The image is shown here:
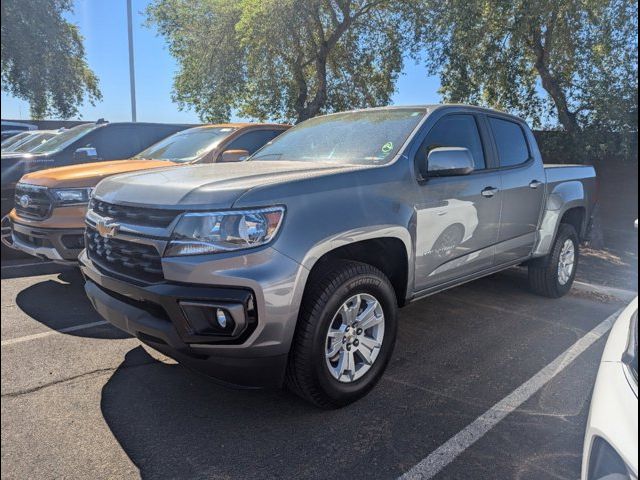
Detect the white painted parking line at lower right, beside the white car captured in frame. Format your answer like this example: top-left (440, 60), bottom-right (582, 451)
top-left (400, 309), bottom-right (622, 480)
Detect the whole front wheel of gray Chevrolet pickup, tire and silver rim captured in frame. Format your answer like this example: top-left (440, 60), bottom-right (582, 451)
top-left (287, 261), bottom-right (397, 408)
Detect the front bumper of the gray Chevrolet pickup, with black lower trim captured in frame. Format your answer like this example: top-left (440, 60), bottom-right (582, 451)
top-left (79, 252), bottom-right (301, 388)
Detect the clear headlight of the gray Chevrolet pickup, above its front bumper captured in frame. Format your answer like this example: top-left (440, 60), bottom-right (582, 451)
top-left (164, 207), bottom-right (284, 257)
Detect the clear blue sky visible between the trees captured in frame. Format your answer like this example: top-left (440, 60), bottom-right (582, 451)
top-left (1, 0), bottom-right (440, 123)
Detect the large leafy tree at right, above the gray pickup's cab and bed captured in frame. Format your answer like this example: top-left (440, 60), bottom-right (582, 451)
top-left (423, 0), bottom-right (638, 134)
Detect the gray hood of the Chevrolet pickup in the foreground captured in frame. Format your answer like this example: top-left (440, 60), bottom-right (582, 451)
top-left (95, 161), bottom-right (363, 209)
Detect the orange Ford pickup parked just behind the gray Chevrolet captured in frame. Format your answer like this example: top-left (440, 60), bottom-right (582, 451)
top-left (8, 123), bottom-right (289, 263)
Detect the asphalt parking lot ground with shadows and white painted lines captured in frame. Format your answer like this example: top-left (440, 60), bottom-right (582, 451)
top-left (2, 260), bottom-right (630, 480)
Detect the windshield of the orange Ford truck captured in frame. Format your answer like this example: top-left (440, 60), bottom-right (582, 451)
top-left (133, 127), bottom-right (237, 163)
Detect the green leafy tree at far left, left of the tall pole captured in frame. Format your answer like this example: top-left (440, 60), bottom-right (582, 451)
top-left (1, 0), bottom-right (102, 119)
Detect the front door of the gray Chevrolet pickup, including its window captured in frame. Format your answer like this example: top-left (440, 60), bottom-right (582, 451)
top-left (415, 113), bottom-right (502, 291)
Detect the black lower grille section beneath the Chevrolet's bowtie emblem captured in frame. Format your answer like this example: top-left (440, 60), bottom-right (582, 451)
top-left (85, 225), bottom-right (164, 283)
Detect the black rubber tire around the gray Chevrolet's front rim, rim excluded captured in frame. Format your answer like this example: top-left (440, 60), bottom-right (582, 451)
top-left (286, 261), bottom-right (397, 408)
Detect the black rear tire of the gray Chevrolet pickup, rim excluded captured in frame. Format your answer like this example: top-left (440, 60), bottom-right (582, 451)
top-left (529, 223), bottom-right (580, 298)
